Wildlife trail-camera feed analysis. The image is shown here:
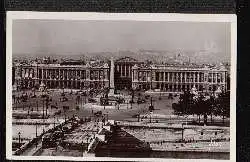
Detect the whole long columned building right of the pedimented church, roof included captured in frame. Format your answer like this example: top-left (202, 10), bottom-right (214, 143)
top-left (132, 64), bottom-right (227, 92)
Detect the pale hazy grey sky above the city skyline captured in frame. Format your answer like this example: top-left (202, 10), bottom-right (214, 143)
top-left (12, 20), bottom-right (231, 57)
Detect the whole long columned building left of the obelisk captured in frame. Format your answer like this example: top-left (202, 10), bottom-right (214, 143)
top-left (12, 63), bottom-right (109, 89)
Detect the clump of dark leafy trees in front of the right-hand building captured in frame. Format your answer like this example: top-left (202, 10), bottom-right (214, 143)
top-left (172, 91), bottom-right (230, 124)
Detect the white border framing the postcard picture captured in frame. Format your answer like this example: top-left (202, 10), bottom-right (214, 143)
top-left (6, 11), bottom-right (237, 162)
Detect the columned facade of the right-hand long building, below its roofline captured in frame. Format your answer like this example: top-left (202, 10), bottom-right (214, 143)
top-left (132, 69), bottom-right (226, 92)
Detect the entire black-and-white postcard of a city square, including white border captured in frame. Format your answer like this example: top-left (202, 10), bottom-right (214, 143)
top-left (6, 12), bottom-right (236, 161)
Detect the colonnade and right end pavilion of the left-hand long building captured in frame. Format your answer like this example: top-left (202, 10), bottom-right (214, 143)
top-left (39, 68), bottom-right (109, 89)
